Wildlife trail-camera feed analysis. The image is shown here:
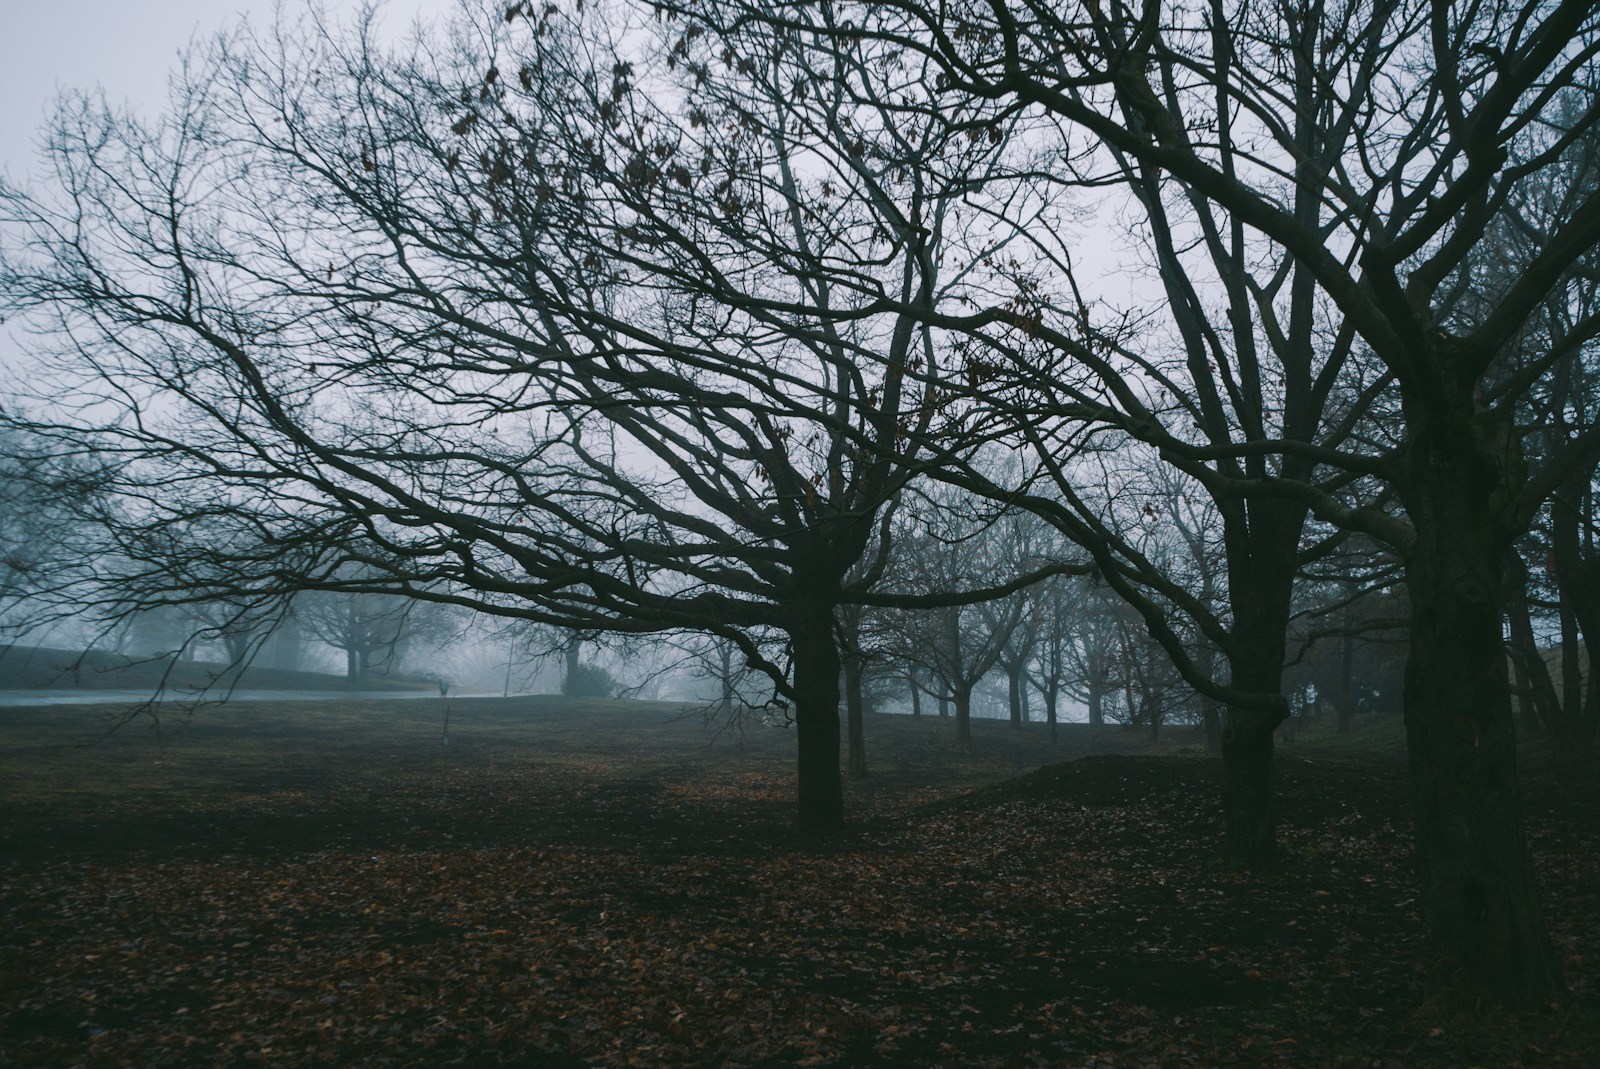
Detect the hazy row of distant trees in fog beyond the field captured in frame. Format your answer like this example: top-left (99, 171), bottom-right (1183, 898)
top-left (0, 422), bottom-right (1408, 726)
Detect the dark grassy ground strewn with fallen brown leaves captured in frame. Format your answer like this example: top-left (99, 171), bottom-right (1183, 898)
top-left (0, 699), bottom-right (1600, 1069)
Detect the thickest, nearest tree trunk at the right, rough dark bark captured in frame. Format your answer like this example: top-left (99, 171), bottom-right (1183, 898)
top-left (1402, 404), bottom-right (1562, 1008)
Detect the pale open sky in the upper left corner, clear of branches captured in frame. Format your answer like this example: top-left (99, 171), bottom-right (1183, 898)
top-left (0, 0), bottom-right (438, 179)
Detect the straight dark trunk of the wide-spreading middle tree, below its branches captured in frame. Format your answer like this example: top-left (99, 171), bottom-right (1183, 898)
top-left (790, 608), bottom-right (845, 832)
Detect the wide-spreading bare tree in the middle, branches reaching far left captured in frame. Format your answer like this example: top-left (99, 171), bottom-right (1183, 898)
top-left (0, 5), bottom-right (1056, 827)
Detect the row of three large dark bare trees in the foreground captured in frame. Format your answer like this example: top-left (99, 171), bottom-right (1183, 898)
top-left (0, 0), bottom-right (1600, 1003)
